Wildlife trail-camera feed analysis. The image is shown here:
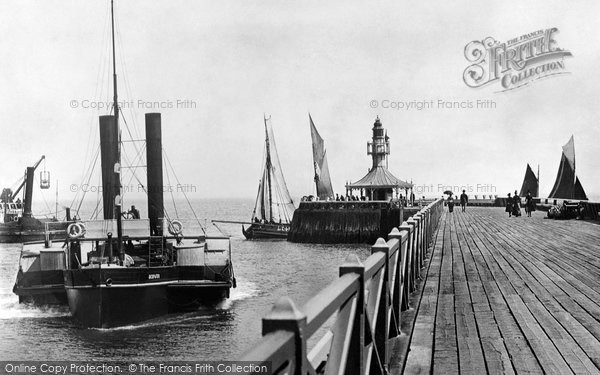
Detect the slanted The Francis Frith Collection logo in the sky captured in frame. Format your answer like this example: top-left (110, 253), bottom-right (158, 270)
top-left (463, 28), bottom-right (572, 91)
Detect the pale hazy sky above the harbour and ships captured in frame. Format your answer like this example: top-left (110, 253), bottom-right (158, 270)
top-left (0, 0), bottom-right (600, 209)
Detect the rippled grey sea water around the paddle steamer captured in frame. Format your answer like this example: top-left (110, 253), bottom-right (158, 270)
top-left (0, 199), bottom-right (370, 361)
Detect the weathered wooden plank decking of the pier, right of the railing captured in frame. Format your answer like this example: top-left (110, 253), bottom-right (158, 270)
top-left (399, 207), bottom-right (600, 374)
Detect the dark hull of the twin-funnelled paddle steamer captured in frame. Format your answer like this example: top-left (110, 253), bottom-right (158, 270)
top-left (65, 266), bottom-right (232, 328)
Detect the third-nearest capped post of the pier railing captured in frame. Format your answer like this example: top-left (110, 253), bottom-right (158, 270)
top-left (370, 237), bottom-right (390, 374)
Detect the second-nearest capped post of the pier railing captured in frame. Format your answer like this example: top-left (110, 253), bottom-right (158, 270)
top-left (336, 254), bottom-right (366, 374)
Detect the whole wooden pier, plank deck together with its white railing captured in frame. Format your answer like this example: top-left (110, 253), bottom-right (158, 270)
top-left (243, 201), bottom-right (600, 374)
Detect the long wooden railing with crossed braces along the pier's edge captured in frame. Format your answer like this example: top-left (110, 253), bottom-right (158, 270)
top-left (242, 199), bottom-right (443, 374)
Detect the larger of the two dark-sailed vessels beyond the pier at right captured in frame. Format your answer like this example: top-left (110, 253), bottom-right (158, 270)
top-left (548, 136), bottom-right (588, 200)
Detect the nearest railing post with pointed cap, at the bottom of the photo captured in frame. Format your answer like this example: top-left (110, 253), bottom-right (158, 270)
top-left (262, 297), bottom-right (310, 374)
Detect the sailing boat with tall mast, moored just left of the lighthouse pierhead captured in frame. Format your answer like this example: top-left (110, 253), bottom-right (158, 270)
top-left (242, 117), bottom-right (295, 239)
